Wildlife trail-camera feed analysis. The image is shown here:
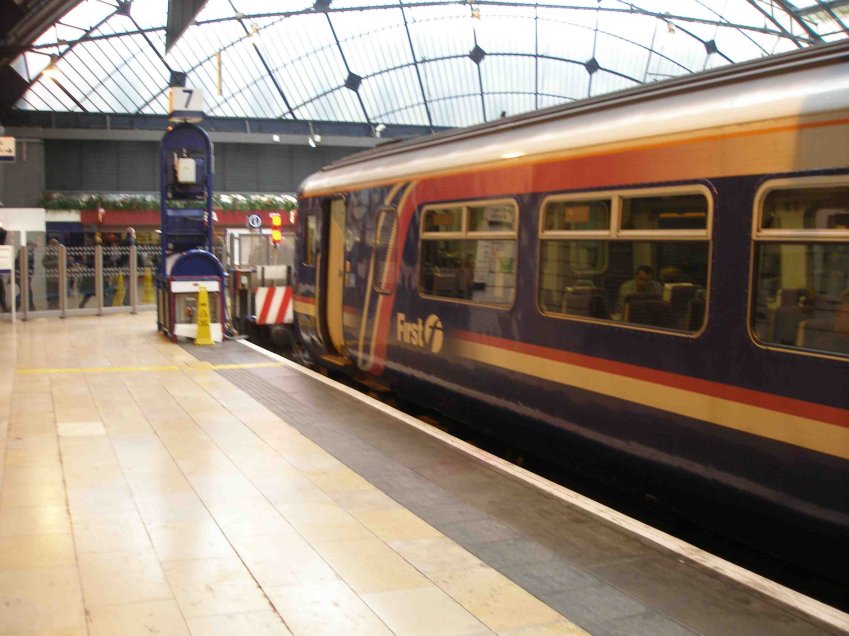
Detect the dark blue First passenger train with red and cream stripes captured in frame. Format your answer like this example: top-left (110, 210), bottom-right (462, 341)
top-left (295, 42), bottom-right (849, 581)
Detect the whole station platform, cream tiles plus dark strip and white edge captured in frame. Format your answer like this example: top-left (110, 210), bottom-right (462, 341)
top-left (0, 314), bottom-right (849, 636)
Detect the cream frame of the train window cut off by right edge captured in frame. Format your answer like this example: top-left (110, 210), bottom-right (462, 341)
top-left (746, 174), bottom-right (849, 362)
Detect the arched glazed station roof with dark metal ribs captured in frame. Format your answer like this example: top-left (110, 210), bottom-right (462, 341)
top-left (8, 0), bottom-right (849, 128)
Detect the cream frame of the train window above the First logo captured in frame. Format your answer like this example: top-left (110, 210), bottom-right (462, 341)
top-left (416, 197), bottom-right (521, 311)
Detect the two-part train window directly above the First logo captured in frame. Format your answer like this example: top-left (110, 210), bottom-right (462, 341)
top-left (419, 199), bottom-right (518, 307)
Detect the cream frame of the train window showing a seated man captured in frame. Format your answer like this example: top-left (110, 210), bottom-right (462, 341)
top-left (536, 182), bottom-right (714, 338)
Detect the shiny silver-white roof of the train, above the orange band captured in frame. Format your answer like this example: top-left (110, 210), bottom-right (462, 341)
top-left (300, 40), bottom-right (849, 195)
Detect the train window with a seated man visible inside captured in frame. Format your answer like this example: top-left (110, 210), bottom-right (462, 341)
top-left (538, 186), bottom-right (711, 333)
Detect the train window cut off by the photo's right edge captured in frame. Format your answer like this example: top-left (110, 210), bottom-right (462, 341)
top-left (750, 177), bottom-right (849, 355)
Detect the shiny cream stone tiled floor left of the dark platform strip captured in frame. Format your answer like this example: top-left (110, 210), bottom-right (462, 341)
top-left (0, 314), bottom-right (582, 636)
